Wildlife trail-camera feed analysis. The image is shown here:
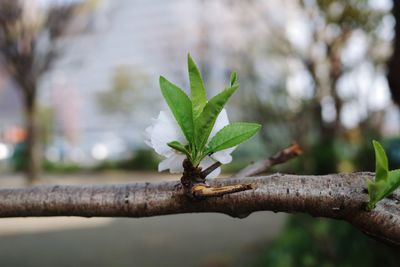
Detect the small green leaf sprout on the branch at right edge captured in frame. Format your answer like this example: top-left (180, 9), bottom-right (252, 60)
top-left (367, 140), bottom-right (400, 210)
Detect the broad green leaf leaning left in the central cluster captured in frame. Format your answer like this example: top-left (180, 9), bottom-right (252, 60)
top-left (160, 76), bottom-right (194, 143)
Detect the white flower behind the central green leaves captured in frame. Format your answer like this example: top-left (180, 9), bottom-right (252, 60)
top-left (145, 109), bottom-right (235, 178)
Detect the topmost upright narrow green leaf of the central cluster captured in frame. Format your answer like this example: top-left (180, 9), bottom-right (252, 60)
top-left (188, 54), bottom-right (207, 118)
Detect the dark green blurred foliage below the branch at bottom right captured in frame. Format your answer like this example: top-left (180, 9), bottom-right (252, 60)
top-left (254, 215), bottom-right (398, 267)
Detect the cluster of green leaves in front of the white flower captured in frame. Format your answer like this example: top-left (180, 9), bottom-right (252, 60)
top-left (160, 54), bottom-right (261, 166)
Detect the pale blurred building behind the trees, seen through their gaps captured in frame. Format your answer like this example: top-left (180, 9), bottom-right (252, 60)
top-left (0, 0), bottom-right (398, 163)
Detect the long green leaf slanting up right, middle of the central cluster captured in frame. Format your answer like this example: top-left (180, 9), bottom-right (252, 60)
top-left (194, 84), bottom-right (239, 151)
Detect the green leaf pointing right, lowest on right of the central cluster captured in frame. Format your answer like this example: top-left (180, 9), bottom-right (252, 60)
top-left (208, 122), bottom-right (261, 153)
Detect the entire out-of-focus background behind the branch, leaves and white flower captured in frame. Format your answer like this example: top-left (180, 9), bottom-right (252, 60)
top-left (0, 0), bottom-right (400, 266)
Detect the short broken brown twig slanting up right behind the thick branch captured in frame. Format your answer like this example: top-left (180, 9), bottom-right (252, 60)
top-left (233, 143), bottom-right (303, 177)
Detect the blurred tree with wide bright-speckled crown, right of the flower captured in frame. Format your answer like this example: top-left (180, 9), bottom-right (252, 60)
top-left (230, 0), bottom-right (390, 174)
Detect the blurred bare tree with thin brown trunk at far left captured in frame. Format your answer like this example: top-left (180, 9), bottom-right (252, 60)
top-left (0, 0), bottom-right (82, 182)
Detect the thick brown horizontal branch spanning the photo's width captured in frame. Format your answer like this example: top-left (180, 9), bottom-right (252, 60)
top-left (0, 173), bottom-right (400, 246)
